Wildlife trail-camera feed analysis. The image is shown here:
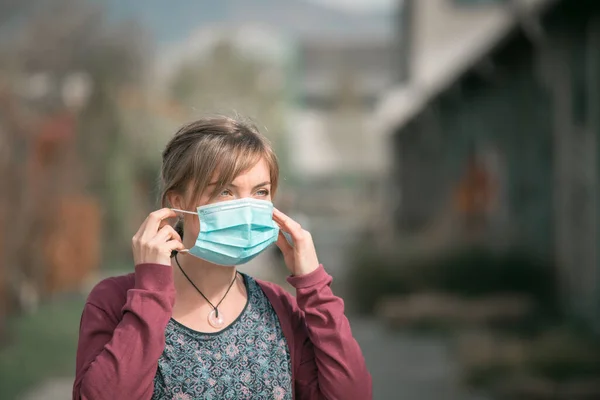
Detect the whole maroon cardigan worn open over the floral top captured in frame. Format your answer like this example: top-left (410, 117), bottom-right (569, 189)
top-left (73, 264), bottom-right (372, 400)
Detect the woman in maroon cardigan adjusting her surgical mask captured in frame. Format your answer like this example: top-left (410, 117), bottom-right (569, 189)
top-left (73, 118), bottom-right (372, 400)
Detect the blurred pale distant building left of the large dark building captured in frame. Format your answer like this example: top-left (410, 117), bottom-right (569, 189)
top-left (290, 36), bottom-right (394, 181)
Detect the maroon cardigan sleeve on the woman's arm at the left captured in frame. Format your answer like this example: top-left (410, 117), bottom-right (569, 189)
top-left (73, 264), bottom-right (175, 400)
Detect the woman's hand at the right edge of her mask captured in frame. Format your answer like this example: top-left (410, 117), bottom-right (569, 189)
top-left (273, 209), bottom-right (319, 276)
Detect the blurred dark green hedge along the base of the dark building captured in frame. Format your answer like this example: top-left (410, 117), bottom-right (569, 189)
top-left (350, 242), bottom-right (558, 315)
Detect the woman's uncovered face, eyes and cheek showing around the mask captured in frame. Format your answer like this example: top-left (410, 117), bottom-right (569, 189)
top-left (183, 159), bottom-right (272, 248)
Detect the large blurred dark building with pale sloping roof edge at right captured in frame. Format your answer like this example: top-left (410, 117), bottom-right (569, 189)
top-left (376, 0), bottom-right (600, 328)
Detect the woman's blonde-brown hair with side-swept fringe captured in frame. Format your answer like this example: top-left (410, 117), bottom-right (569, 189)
top-left (160, 117), bottom-right (279, 207)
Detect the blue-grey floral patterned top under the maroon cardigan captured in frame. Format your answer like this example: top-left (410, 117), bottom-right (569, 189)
top-left (152, 274), bottom-right (292, 400)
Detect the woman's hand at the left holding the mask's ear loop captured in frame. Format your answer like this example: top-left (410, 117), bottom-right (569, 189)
top-left (132, 208), bottom-right (185, 265)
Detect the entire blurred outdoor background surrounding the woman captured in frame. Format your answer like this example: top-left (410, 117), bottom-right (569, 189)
top-left (0, 0), bottom-right (600, 400)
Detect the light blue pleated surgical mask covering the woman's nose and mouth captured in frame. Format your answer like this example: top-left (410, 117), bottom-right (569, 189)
top-left (173, 198), bottom-right (279, 266)
